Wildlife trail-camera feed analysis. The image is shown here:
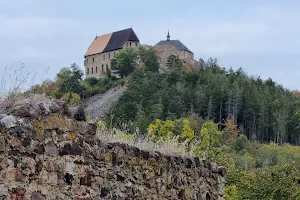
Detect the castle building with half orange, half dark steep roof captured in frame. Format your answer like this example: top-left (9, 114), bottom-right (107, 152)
top-left (84, 28), bottom-right (140, 78)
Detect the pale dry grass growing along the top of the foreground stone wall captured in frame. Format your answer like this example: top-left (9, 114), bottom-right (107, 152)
top-left (96, 127), bottom-right (190, 156)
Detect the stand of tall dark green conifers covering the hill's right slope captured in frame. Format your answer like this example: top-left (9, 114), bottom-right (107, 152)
top-left (112, 55), bottom-right (300, 145)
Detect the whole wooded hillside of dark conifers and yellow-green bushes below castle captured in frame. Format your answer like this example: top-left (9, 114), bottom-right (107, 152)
top-left (29, 48), bottom-right (300, 200)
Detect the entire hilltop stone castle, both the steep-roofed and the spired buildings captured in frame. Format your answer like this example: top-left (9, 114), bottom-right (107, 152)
top-left (84, 28), bottom-right (197, 78)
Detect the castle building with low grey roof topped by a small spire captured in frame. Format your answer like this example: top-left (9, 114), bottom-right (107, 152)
top-left (153, 31), bottom-right (197, 70)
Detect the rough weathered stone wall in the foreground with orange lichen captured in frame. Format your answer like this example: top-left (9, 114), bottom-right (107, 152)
top-left (0, 99), bottom-right (226, 200)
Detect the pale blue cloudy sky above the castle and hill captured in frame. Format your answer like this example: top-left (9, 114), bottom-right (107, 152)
top-left (0, 0), bottom-right (300, 90)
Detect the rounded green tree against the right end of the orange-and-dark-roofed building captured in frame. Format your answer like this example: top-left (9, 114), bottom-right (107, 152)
top-left (112, 47), bottom-right (138, 78)
